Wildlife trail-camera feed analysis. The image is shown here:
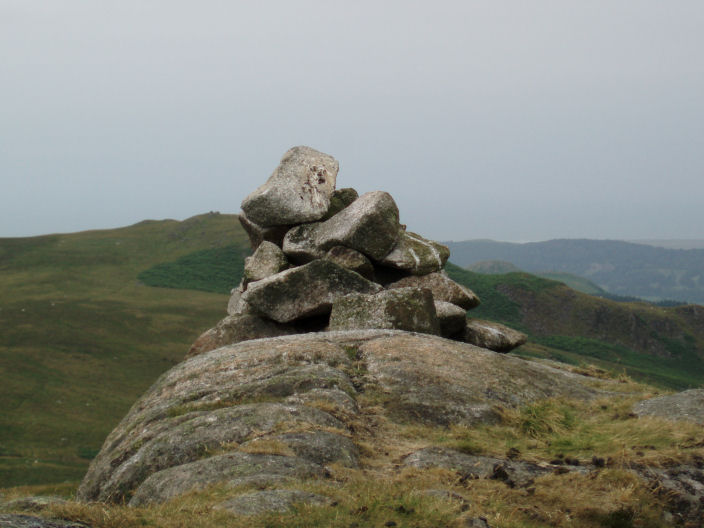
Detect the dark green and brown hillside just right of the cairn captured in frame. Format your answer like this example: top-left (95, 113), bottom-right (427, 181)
top-left (447, 264), bottom-right (704, 388)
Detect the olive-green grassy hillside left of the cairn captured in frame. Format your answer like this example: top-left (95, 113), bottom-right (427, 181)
top-left (0, 213), bottom-right (248, 487)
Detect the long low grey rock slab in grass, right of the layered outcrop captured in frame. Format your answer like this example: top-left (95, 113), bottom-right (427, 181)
top-left (403, 447), bottom-right (552, 488)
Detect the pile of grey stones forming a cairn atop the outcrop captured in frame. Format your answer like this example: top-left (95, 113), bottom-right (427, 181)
top-left (187, 146), bottom-right (525, 357)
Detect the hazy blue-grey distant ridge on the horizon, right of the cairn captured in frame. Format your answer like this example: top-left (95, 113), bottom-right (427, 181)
top-left (447, 239), bottom-right (704, 304)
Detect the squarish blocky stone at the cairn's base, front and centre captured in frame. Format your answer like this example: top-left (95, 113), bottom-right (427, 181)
top-left (329, 288), bottom-right (440, 335)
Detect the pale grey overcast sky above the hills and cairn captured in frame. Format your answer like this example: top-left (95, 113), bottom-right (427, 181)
top-left (0, 0), bottom-right (704, 241)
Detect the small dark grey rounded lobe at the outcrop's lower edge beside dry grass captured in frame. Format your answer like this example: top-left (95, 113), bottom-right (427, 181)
top-left (242, 431), bottom-right (359, 467)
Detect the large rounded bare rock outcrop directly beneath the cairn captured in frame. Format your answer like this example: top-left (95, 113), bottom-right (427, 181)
top-left (78, 330), bottom-right (597, 505)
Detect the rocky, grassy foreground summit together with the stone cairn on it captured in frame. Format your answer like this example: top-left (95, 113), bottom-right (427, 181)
top-left (37, 147), bottom-right (704, 528)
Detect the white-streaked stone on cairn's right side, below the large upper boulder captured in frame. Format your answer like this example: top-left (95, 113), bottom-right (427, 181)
top-left (377, 231), bottom-right (450, 275)
